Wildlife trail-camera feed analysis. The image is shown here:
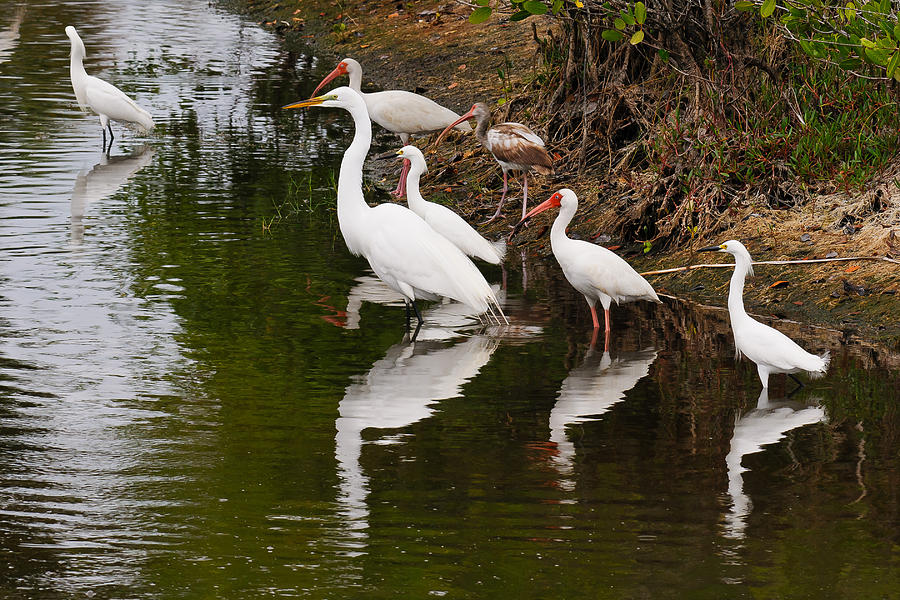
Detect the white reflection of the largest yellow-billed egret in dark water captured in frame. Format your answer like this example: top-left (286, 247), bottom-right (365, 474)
top-left (335, 330), bottom-right (499, 548)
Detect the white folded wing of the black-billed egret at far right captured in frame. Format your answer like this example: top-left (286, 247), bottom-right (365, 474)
top-left (731, 316), bottom-right (827, 372)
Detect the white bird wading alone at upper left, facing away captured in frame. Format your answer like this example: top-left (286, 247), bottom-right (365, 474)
top-left (66, 25), bottom-right (155, 149)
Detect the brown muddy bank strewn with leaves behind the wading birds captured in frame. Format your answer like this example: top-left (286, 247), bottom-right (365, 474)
top-left (221, 0), bottom-right (900, 352)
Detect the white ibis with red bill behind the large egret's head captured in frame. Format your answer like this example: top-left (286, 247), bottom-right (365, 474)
top-left (312, 58), bottom-right (472, 197)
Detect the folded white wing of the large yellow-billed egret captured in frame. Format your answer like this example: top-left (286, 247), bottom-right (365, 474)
top-left (366, 204), bottom-right (497, 312)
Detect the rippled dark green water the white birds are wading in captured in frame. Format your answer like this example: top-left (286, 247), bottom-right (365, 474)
top-left (0, 0), bottom-right (900, 599)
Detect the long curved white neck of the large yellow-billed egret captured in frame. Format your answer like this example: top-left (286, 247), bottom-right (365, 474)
top-left (337, 102), bottom-right (372, 246)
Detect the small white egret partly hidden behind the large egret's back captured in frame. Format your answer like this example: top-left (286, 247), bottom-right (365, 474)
top-left (397, 146), bottom-right (503, 265)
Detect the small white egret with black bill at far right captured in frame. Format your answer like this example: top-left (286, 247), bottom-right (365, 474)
top-left (700, 240), bottom-right (829, 388)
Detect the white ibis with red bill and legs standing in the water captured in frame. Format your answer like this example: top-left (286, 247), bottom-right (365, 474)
top-left (523, 188), bottom-right (660, 338)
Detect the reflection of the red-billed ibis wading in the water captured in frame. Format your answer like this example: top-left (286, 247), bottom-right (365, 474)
top-left (550, 341), bottom-right (656, 490)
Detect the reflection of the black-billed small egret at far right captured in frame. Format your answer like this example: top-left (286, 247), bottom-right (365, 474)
top-left (724, 388), bottom-right (825, 539)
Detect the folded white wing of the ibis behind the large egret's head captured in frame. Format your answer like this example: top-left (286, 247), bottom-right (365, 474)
top-left (363, 90), bottom-right (472, 133)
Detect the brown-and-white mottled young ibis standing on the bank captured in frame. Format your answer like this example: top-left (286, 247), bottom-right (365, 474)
top-left (435, 102), bottom-right (553, 223)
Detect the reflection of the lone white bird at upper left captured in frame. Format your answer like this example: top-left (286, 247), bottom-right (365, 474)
top-left (71, 145), bottom-right (153, 244)
